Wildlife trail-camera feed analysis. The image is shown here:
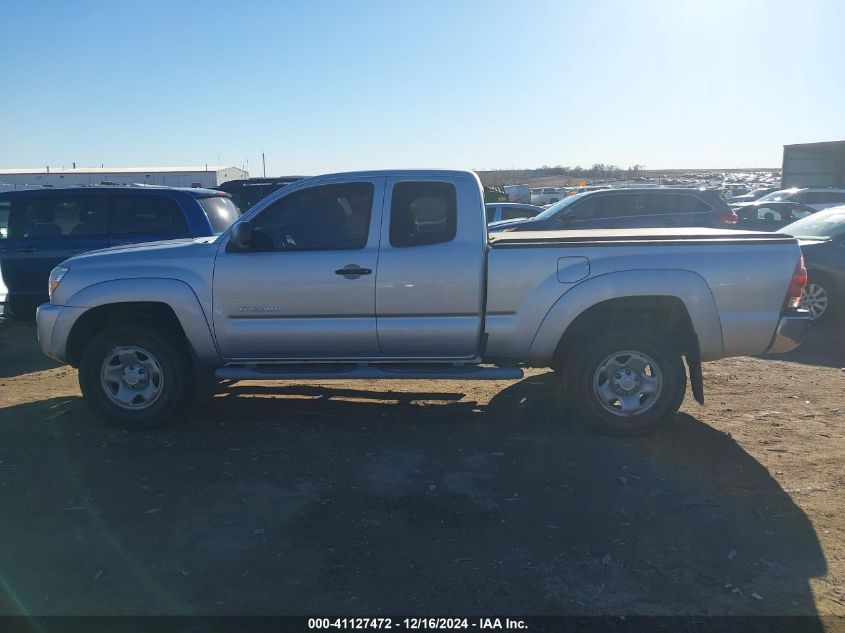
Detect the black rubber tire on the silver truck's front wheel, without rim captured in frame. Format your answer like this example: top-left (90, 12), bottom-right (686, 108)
top-left (79, 323), bottom-right (192, 430)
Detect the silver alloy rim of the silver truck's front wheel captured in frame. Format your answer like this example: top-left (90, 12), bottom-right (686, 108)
top-left (100, 347), bottom-right (163, 410)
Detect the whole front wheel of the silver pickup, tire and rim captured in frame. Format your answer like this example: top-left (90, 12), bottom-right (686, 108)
top-left (79, 323), bottom-right (191, 429)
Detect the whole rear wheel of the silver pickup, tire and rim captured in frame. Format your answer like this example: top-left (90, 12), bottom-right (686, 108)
top-left (566, 332), bottom-right (686, 436)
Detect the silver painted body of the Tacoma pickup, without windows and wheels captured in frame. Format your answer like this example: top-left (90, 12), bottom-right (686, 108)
top-left (38, 171), bottom-right (800, 377)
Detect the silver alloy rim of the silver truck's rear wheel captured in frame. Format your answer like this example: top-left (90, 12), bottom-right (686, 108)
top-left (593, 350), bottom-right (662, 417)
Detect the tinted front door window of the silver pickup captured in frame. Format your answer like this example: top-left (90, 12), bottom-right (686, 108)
top-left (252, 182), bottom-right (375, 251)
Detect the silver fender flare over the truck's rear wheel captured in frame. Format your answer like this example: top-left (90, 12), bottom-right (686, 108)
top-left (528, 269), bottom-right (724, 366)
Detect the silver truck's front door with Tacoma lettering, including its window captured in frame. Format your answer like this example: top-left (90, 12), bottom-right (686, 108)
top-left (213, 177), bottom-right (384, 360)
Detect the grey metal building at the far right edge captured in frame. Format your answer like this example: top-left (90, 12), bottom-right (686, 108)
top-left (783, 141), bottom-right (845, 187)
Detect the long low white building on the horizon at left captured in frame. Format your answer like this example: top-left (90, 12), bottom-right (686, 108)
top-left (0, 166), bottom-right (249, 191)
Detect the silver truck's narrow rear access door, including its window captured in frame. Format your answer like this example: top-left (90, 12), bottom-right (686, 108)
top-left (376, 175), bottom-right (487, 359)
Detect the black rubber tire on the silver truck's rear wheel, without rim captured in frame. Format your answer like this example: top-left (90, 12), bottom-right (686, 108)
top-left (565, 332), bottom-right (687, 437)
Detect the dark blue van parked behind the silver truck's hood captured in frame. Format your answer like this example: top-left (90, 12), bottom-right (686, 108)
top-left (0, 186), bottom-right (238, 317)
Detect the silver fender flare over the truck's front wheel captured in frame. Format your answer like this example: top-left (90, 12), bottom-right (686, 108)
top-left (62, 278), bottom-right (220, 365)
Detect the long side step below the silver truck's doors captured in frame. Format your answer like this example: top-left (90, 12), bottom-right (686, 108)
top-left (214, 363), bottom-right (523, 380)
